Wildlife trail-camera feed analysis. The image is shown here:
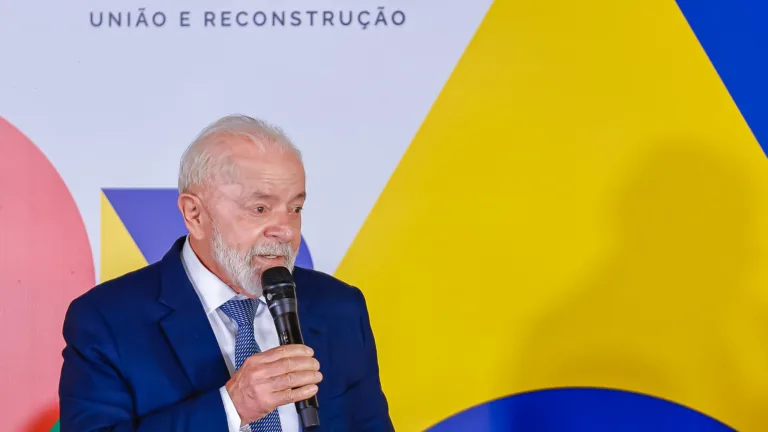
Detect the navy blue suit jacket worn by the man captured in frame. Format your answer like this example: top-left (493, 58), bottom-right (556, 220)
top-left (59, 238), bottom-right (393, 432)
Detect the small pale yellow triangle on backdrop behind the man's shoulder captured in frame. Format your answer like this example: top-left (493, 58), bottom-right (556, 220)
top-left (101, 192), bottom-right (147, 282)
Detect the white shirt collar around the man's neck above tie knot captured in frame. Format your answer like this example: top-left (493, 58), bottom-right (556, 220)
top-left (181, 236), bottom-right (266, 315)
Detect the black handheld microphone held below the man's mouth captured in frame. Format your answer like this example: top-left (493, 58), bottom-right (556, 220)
top-left (261, 267), bottom-right (320, 429)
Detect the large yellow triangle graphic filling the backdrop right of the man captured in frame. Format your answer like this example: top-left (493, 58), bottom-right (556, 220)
top-left (337, 0), bottom-right (768, 431)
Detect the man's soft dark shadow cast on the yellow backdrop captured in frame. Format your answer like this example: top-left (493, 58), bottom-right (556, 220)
top-left (519, 143), bottom-right (768, 424)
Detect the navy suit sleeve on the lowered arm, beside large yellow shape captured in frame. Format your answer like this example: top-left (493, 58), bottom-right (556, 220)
top-left (353, 289), bottom-right (394, 432)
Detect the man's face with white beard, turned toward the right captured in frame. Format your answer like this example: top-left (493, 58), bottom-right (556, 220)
top-left (202, 137), bottom-right (305, 297)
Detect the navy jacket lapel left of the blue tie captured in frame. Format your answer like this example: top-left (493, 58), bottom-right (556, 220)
top-left (159, 238), bottom-right (229, 391)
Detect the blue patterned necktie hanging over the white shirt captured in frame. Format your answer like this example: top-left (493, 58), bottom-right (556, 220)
top-left (220, 299), bottom-right (282, 432)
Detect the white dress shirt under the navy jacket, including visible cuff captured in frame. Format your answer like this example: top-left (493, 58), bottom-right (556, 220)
top-left (181, 237), bottom-right (299, 432)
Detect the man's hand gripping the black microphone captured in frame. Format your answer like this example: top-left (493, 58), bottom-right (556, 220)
top-left (226, 344), bottom-right (323, 425)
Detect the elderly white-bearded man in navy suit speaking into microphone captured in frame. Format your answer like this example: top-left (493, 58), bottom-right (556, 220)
top-left (59, 116), bottom-right (393, 432)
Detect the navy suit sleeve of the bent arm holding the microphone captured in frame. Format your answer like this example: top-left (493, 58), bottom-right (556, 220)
top-left (59, 297), bottom-right (228, 432)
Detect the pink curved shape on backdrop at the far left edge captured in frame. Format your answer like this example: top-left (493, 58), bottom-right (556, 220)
top-left (0, 117), bottom-right (95, 432)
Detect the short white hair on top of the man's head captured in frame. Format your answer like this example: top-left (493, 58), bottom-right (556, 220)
top-left (178, 115), bottom-right (302, 193)
